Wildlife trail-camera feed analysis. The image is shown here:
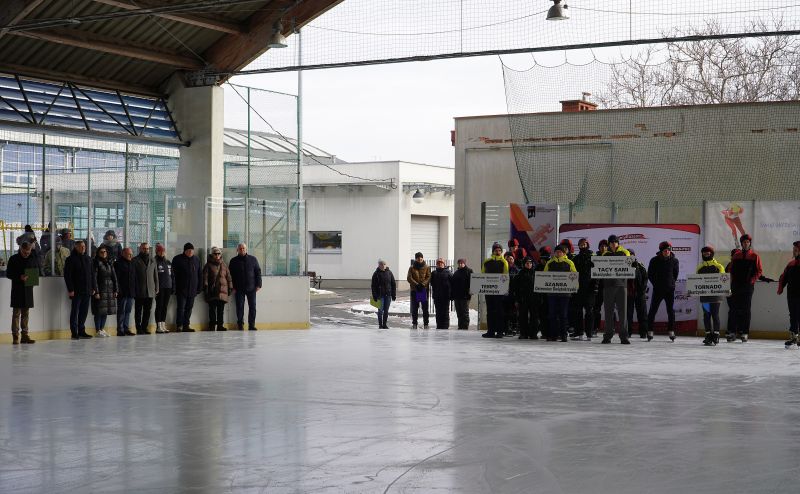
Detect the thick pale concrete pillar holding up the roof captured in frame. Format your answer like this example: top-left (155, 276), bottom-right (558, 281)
top-left (168, 77), bottom-right (225, 255)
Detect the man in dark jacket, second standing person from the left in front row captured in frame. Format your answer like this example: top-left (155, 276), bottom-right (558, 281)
top-left (64, 240), bottom-right (92, 340)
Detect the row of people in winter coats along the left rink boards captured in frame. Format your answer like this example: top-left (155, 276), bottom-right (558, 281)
top-left (6, 240), bottom-right (261, 344)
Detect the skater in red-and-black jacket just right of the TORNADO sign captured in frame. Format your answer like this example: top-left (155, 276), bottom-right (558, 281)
top-left (726, 233), bottom-right (763, 343)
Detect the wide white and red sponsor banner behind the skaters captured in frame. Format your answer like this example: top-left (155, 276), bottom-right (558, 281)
top-left (559, 224), bottom-right (700, 332)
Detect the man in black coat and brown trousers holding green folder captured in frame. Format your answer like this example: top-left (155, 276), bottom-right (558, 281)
top-left (6, 242), bottom-right (39, 345)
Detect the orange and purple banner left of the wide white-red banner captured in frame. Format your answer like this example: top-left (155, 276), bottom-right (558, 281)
top-left (509, 204), bottom-right (558, 252)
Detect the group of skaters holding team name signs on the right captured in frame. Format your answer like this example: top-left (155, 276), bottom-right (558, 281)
top-left (482, 234), bottom-right (800, 346)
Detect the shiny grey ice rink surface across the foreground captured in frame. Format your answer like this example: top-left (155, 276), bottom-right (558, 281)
top-left (0, 328), bottom-right (800, 494)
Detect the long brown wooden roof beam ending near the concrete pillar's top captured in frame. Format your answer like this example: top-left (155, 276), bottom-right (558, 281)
top-left (9, 29), bottom-right (205, 70)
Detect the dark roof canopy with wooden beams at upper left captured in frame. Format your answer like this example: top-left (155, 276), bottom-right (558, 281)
top-left (0, 0), bottom-right (341, 97)
